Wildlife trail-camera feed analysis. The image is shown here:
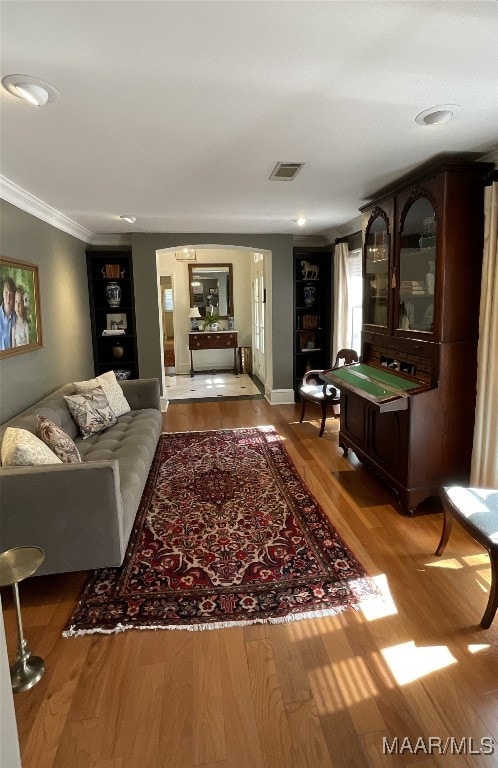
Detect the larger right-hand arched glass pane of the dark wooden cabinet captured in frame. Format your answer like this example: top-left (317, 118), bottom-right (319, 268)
top-left (395, 197), bottom-right (436, 333)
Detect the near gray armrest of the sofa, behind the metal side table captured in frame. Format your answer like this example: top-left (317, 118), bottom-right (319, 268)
top-left (0, 459), bottom-right (127, 575)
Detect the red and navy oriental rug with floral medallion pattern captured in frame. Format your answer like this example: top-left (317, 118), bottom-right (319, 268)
top-left (64, 427), bottom-right (378, 637)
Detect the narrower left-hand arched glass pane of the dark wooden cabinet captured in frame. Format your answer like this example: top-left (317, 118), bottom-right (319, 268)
top-left (363, 215), bottom-right (389, 328)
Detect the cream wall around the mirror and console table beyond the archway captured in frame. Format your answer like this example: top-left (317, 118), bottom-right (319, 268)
top-left (158, 246), bottom-right (253, 374)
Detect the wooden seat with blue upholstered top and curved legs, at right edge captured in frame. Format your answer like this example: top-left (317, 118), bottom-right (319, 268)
top-left (436, 486), bottom-right (498, 629)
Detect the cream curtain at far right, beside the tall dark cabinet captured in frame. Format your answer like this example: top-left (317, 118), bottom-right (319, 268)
top-left (470, 183), bottom-right (498, 488)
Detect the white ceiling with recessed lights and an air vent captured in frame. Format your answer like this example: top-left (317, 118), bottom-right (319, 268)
top-left (0, 0), bottom-right (498, 239)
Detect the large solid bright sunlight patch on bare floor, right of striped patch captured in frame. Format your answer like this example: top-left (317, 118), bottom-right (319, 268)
top-left (382, 640), bottom-right (457, 685)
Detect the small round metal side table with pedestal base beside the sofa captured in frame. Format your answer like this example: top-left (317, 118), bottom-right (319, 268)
top-left (0, 547), bottom-right (45, 693)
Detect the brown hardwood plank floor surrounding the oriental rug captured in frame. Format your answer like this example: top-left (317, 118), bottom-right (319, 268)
top-left (2, 400), bottom-right (498, 768)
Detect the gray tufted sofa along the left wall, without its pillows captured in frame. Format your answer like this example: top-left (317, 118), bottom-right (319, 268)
top-left (0, 379), bottom-right (162, 575)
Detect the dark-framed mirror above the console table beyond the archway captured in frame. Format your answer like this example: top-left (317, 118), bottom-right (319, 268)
top-left (188, 264), bottom-right (234, 317)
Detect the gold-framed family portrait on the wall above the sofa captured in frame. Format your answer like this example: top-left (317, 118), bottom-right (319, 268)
top-left (0, 256), bottom-right (43, 359)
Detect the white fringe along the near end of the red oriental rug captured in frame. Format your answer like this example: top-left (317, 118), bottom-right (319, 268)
top-left (62, 603), bottom-right (361, 638)
